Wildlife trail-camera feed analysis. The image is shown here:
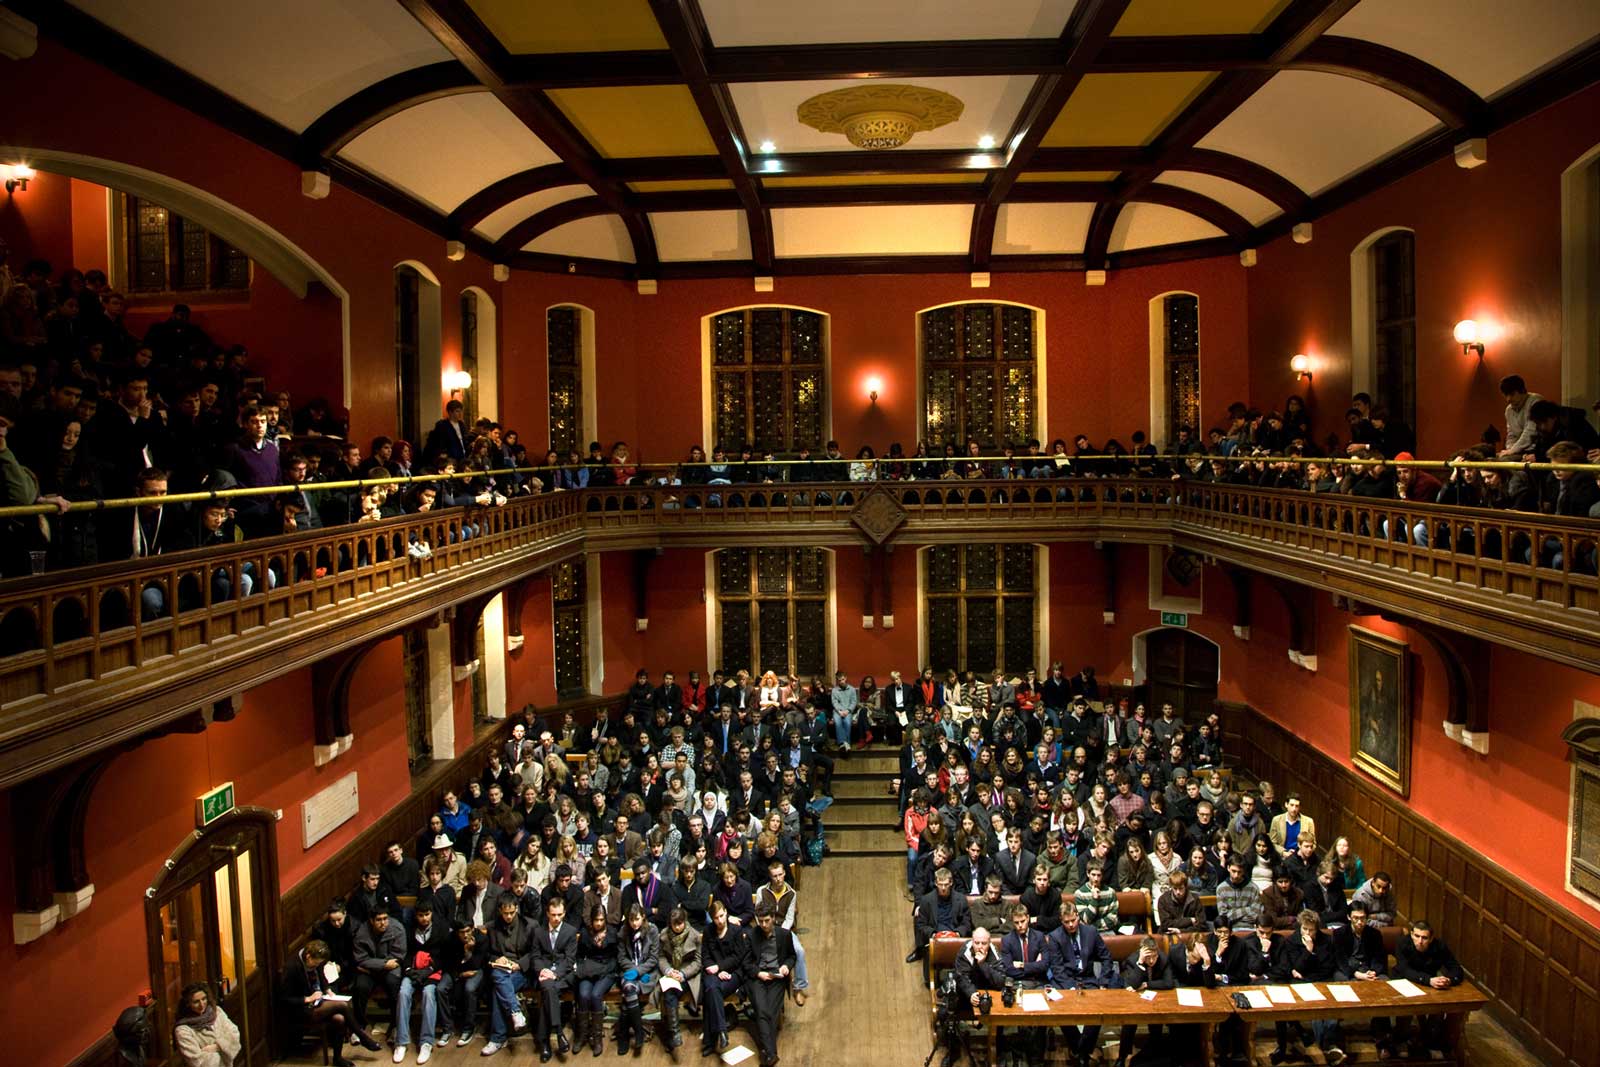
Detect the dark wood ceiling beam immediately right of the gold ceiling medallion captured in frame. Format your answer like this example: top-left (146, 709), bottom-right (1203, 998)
top-left (966, 0), bottom-right (1130, 270)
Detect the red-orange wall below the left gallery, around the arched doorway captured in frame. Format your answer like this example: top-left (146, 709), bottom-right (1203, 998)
top-left (0, 638), bottom-right (411, 1064)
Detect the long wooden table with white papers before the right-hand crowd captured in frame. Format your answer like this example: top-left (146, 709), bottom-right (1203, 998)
top-left (978, 979), bottom-right (1488, 1067)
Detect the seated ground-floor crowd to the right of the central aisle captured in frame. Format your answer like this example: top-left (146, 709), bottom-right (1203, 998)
top-left (891, 664), bottom-right (1462, 1067)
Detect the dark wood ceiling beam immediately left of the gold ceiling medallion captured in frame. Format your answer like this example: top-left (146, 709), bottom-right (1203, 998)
top-left (650, 0), bottom-right (776, 275)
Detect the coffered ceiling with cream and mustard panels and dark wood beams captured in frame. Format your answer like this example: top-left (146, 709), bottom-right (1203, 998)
top-left (31, 0), bottom-right (1600, 277)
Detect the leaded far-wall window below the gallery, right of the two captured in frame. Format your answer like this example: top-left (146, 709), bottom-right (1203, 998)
top-left (923, 544), bottom-right (1037, 673)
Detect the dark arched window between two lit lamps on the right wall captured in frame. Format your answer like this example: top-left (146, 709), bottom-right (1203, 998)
top-left (1350, 227), bottom-right (1416, 426)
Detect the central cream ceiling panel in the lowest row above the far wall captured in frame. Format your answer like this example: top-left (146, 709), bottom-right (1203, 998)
top-left (773, 203), bottom-right (973, 256)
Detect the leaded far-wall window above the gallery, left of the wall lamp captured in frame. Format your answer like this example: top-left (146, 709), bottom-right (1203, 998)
top-left (710, 307), bottom-right (827, 453)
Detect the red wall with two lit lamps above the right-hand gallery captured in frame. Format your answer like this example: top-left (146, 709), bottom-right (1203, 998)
top-left (1248, 79), bottom-right (1600, 458)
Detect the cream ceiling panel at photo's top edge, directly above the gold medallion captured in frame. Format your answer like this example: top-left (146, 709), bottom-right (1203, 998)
top-left (701, 0), bottom-right (1075, 48)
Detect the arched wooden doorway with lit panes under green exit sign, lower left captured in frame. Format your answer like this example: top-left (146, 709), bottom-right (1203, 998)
top-left (144, 808), bottom-right (278, 1067)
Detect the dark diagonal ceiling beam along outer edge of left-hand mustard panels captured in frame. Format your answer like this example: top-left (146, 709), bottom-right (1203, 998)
top-left (400, 0), bottom-right (659, 277)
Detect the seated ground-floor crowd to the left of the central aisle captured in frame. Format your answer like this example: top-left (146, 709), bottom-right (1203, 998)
top-left (291, 670), bottom-right (838, 1067)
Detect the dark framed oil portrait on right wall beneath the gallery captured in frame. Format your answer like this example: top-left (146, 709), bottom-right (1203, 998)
top-left (1350, 625), bottom-right (1411, 797)
